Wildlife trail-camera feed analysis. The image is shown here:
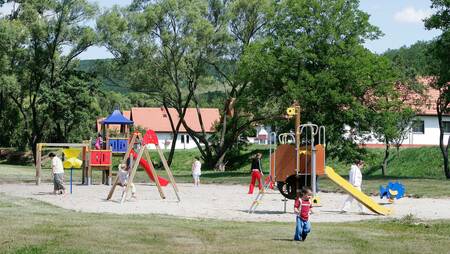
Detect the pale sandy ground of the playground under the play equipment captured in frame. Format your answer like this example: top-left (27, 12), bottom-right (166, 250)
top-left (0, 184), bottom-right (450, 222)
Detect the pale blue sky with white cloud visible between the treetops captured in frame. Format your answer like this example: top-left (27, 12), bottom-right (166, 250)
top-left (0, 0), bottom-right (440, 59)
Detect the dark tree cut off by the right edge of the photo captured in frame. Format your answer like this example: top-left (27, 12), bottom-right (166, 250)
top-left (425, 0), bottom-right (450, 179)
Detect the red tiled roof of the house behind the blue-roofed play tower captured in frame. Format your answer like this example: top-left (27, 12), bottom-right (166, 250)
top-left (131, 108), bottom-right (220, 132)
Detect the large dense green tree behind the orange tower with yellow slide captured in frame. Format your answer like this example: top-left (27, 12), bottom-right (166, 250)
top-left (239, 0), bottom-right (396, 160)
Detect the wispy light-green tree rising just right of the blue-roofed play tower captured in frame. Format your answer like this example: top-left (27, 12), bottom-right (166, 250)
top-left (97, 0), bottom-right (225, 164)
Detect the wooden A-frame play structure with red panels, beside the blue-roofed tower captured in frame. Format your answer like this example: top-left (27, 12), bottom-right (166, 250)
top-left (106, 130), bottom-right (180, 203)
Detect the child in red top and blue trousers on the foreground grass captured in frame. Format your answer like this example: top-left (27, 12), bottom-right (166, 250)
top-left (294, 187), bottom-right (312, 241)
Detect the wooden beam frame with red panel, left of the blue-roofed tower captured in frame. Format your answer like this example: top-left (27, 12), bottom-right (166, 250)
top-left (35, 143), bottom-right (112, 185)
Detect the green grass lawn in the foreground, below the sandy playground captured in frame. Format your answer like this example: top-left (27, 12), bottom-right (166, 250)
top-left (0, 195), bottom-right (450, 254)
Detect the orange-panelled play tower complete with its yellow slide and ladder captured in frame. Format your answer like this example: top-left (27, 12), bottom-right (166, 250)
top-left (249, 104), bottom-right (391, 215)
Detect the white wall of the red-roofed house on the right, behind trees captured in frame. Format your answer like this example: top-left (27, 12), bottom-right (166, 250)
top-left (344, 116), bottom-right (450, 145)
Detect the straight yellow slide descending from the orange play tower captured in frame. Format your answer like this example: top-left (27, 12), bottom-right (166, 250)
top-left (325, 166), bottom-right (392, 215)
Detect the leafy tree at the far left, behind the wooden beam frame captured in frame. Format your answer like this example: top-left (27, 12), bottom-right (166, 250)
top-left (0, 0), bottom-right (96, 161)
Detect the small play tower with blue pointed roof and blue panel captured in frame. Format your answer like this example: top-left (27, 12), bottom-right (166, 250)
top-left (101, 109), bottom-right (133, 154)
